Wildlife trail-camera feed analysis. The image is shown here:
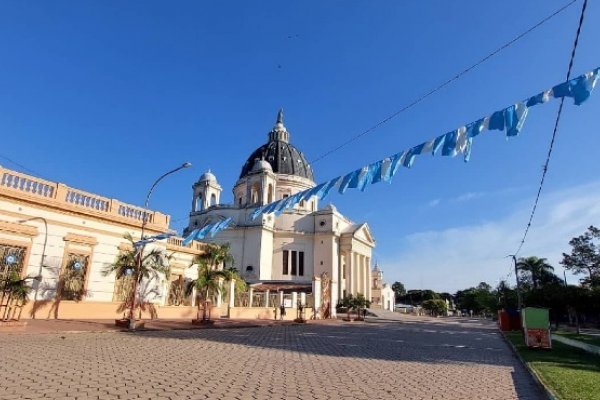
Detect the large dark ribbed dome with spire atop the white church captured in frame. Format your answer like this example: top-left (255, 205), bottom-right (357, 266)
top-left (240, 110), bottom-right (314, 181)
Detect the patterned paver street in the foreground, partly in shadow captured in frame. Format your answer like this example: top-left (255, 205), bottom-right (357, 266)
top-left (0, 320), bottom-right (543, 400)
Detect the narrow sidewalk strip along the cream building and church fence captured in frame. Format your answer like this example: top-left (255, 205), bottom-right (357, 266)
top-left (0, 318), bottom-right (325, 335)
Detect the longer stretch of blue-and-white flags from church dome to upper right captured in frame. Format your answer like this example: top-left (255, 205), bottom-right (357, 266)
top-left (250, 68), bottom-right (600, 220)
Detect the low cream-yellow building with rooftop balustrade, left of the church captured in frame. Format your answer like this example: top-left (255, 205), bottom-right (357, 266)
top-left (0, 167), bottom-right (206, 319)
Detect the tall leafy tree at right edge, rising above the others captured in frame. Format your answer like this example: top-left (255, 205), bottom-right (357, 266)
top-left (560, 225), bottom-right (600, 286)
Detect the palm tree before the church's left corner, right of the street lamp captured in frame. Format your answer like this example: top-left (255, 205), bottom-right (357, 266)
top-left (186, 243), bottom-right (237, 321)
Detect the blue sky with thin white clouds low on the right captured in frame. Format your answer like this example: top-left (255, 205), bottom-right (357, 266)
top-left (0, 0), bottom-right (600, 291)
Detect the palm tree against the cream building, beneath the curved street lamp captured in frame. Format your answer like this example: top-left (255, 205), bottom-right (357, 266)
top-left (102, 234), bottom-right (171, 318)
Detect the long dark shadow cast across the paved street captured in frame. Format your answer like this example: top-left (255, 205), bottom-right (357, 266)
top-left (134, 321), bottom-right (532, 366)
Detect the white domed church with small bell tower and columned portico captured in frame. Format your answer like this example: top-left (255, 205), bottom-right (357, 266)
top-left (184, 111), bottom-right (375, 315)
